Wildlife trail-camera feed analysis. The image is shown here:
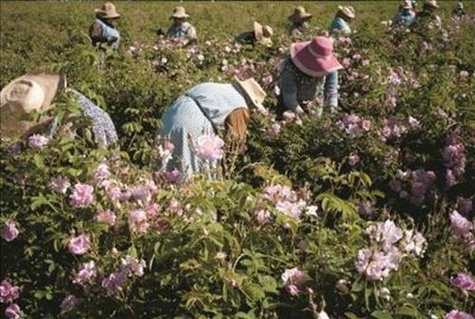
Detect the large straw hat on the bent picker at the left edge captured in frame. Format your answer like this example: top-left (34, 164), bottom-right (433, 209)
top-left (0, 73), bottom-right (66, 136)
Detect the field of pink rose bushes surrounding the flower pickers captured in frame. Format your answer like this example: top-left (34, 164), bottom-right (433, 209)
top-left (0, 0), bottom-right (475, 319)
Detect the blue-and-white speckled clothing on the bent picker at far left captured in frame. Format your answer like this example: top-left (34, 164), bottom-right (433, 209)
top-left (46, 89), bottom-right (118, 147)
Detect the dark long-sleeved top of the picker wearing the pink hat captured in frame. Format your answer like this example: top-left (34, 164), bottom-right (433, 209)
top-left (278, 58), bottom-right (338, 115)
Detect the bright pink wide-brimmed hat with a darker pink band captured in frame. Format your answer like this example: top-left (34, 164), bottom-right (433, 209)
top-left (290, 36), bottom-right (343, 77)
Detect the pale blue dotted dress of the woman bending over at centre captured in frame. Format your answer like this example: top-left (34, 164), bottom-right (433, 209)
top-left (158, 83), bottom-right (247, 178)
